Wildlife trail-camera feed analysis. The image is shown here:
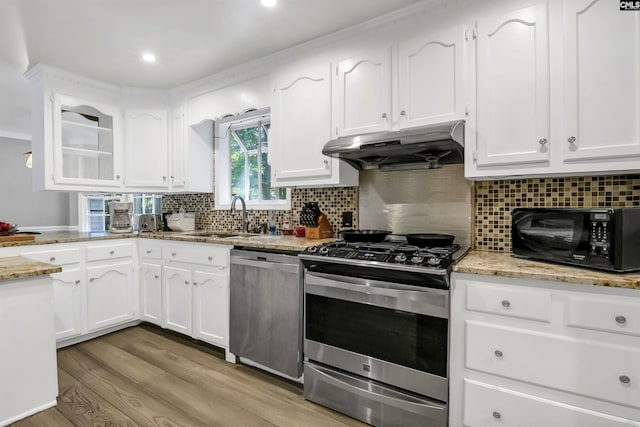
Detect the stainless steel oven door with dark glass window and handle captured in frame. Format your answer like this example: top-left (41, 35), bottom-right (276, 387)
top-left (304, 270), bottom-right (449, 402)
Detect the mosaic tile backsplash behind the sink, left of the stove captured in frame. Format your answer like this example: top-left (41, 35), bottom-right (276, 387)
top-left (162, 187), bottom-right (358, 231)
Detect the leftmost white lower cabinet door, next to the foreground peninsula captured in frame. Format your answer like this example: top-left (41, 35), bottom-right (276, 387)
top-left (51, 268), bottom-right (83, 341)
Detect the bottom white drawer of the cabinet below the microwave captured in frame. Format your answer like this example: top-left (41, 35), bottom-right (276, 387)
top-left (464, 380), bottom-right (640, 427)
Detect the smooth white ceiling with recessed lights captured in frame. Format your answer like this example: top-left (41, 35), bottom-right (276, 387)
top-left (0, 0), bottom-right (422, 88)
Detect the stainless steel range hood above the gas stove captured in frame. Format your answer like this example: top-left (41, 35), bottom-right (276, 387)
top-left (322, 120), bottom-right (464, 170)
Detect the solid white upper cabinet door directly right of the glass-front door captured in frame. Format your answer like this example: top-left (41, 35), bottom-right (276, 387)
top-left (125, 110), bottom-right (168, 188)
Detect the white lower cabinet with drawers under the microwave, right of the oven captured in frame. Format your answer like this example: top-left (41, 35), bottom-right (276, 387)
top-left (449, 273), bottom-right (640, 427)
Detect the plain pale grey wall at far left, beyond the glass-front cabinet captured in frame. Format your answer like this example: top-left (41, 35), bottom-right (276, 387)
top-left (0, 137), bottom-right (78, 227)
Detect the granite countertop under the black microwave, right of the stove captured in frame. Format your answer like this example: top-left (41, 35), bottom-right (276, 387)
top-left (454, 251), bottom-right (640, 289)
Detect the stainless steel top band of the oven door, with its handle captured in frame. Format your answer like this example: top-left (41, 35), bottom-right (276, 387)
top-left (304, 271), bottom-right (449, 319)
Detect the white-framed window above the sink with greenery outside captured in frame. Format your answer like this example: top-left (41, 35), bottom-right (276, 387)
top-left (215, 108), bottom-right (291, 209)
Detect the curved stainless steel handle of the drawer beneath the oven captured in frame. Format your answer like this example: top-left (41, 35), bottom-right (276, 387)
top-left (312, 364), bottom-right (447, 413)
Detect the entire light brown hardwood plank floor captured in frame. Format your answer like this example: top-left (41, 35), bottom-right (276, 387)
top-left (12, 325), bottom-right (365, 427)
